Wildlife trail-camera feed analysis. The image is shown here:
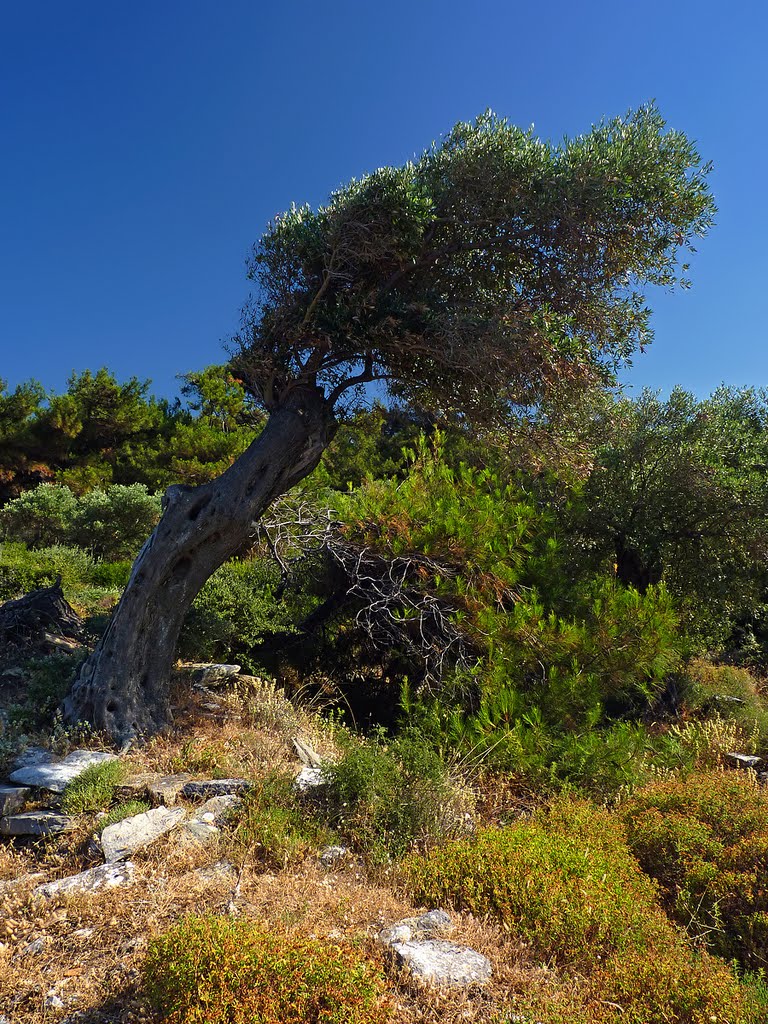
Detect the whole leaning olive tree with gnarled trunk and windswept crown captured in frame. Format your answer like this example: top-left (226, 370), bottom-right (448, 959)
top-left (65, 106), bottom-right (714, 741)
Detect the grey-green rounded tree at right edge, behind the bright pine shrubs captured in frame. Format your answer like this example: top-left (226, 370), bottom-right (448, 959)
top-left (572, 388), bottom-right (768, 643)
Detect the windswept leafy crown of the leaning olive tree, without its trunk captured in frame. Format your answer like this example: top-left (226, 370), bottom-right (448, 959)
top-left (233, 105), bottom-right (715, 422)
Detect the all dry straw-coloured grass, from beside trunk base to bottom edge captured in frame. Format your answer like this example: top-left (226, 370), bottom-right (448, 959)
top-left (0, 686), bottom-right (577, 1024)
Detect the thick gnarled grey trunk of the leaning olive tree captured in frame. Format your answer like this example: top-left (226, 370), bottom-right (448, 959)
top-left (63, 387), bottom-right (336, 743)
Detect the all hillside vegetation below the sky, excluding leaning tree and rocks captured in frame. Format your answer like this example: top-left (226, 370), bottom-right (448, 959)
top-left (0, 368), bottom-right (768, 1024)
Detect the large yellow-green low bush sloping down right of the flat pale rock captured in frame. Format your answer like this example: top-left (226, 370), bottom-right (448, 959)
top-left (403, 799), bottom-right (744, 1024)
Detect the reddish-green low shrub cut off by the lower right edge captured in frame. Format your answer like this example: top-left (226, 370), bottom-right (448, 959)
top-left (621, 771), bottom-right (768, 971)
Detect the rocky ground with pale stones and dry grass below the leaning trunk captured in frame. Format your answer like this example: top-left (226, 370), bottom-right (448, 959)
top-left (0, 673), bottom-right (550, 1024)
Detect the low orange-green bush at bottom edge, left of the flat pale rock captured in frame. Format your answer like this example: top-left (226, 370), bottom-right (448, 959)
top-left (144, 918), bottom-right (390, 1024)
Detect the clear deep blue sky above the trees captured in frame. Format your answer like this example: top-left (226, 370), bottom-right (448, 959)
top-left (0, 0), bottom-right (768, 394)
